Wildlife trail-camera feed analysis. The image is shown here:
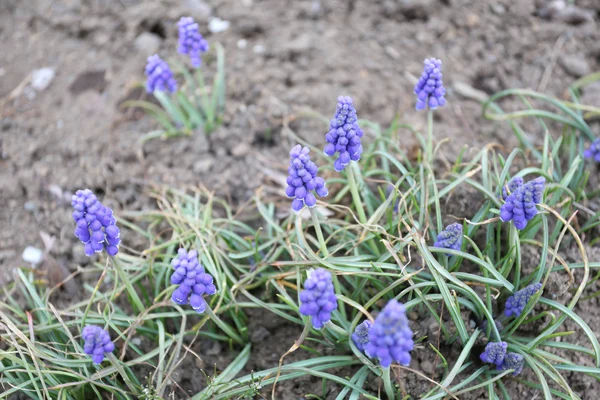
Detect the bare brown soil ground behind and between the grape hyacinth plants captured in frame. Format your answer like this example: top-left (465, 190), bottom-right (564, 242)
top-left (0, 0), bottom-right (600, 399)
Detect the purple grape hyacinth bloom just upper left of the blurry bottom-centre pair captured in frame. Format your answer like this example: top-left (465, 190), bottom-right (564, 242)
top-left (300, 268), bottom-right (337, 329)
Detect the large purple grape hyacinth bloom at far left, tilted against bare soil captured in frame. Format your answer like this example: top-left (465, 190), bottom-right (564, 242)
top-left (71, 189), bottom-right (121, 257)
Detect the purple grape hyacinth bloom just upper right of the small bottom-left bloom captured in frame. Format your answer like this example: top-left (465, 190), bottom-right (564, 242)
top-left (171, 248), bottom-right (217, 313)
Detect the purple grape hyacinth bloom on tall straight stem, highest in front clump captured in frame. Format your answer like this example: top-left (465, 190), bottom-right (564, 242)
top-left (414, 58), bottom-right (446, 110)
